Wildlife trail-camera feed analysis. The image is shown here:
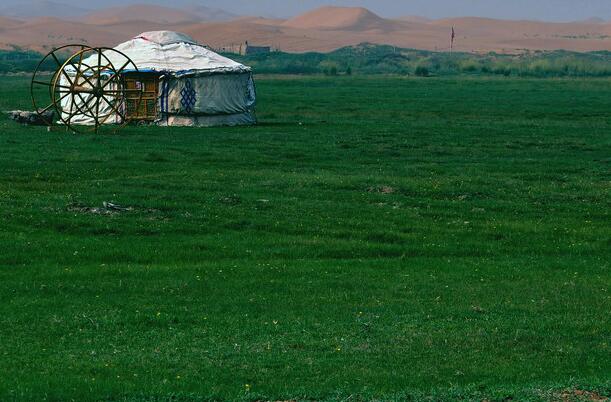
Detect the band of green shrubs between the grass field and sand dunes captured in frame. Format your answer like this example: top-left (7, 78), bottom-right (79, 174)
top-left (0, 44), bottom-right (611, 77)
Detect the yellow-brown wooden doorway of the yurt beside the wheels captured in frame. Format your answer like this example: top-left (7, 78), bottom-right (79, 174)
top-left (125, 73), bottom-right (159, 121)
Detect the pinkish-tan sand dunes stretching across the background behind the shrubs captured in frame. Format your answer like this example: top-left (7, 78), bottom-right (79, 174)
top-left (0, 6), bottom-right (611, 53)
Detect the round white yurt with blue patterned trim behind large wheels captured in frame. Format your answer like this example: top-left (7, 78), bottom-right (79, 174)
top-left (62, 31), bottom-right (256, 127)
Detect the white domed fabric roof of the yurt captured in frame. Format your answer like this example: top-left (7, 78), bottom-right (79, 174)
top-left (77, 31), bottom-right (250, 75)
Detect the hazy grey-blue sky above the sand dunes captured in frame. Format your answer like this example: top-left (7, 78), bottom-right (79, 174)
top-left (0, 0), bottom-right (611, 21)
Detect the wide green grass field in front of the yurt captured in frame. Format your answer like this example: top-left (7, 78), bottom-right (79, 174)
top-left (0, 77), bottom-right (611, 401)
